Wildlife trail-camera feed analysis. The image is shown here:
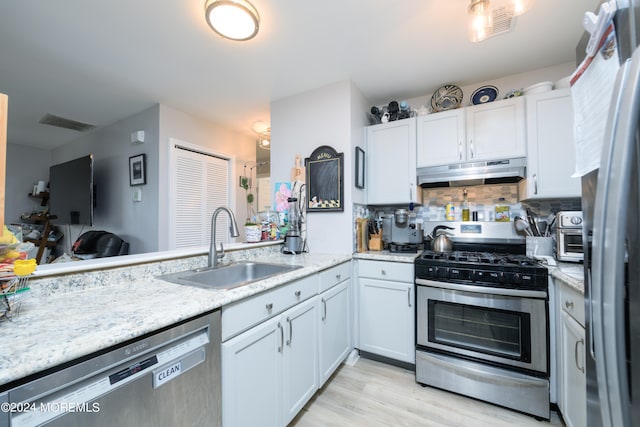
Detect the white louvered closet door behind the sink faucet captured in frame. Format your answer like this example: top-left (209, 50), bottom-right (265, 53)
top-left (172, 146), bottom-right (229, 248)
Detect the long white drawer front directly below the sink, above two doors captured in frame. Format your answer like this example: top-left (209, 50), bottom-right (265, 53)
top-left (222, 274), bottom-right (318, 341)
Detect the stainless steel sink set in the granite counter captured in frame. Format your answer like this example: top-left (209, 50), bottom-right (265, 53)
top-left (159, 261), bottom-right (302, 289)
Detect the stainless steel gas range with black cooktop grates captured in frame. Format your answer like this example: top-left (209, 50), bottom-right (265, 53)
top-left (415, 224), bottom-right (549, 419)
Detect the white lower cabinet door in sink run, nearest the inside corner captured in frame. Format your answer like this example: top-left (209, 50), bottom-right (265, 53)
top-left (318, 280), bottom-right (351, 387)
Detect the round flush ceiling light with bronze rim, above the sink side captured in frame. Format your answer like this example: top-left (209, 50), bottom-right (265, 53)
top-left (204, 0), bottom-right (260, 41)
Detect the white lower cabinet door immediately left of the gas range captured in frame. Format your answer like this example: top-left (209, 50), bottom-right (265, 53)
top-left (359, 278), bottom-right (415, 363)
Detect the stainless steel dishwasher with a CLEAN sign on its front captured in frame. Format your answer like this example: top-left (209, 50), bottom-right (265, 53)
top-left (0, 310), bottom-right (222, 427)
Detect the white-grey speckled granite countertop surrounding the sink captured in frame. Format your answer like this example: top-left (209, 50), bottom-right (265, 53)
top-left (0, 254), bottom-right (352, 389)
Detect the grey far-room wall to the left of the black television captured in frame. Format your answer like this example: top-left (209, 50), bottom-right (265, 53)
top-left (4, 144), bottom-right (51, 224)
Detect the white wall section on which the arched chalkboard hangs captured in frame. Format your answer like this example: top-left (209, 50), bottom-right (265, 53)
top-left (271, 81), bottom-right (367, 253)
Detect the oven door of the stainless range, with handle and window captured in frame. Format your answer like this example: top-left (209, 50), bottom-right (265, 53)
top-left (416, 279), bottom-right (548, 373)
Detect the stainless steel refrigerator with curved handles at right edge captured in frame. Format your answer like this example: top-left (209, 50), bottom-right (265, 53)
top-left (577, 0), bottom-right (640, 427)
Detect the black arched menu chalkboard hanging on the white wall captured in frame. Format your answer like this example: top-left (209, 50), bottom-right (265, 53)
top-left (304, 145), bottom-right (344, 212)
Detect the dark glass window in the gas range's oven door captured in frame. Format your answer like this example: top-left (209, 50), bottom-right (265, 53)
top-left (428, 300), bottom-right (531, 362)
